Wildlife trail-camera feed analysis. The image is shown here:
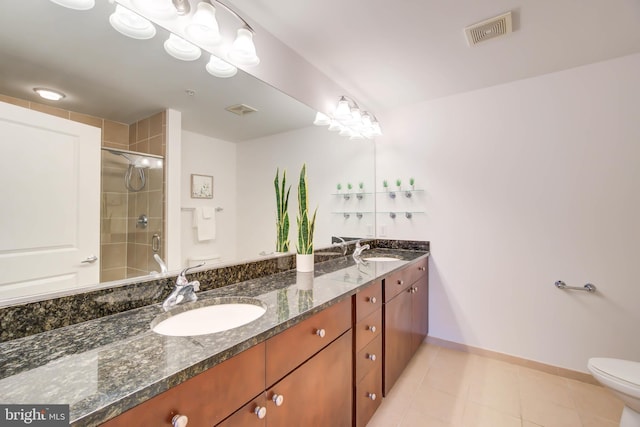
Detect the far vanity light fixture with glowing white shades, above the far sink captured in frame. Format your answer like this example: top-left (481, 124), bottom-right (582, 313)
top-left (313, 96), bottom-right (382, 139)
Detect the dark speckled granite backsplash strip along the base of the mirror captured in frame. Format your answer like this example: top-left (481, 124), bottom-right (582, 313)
top-left (0, 240), bottom-right (429, 342)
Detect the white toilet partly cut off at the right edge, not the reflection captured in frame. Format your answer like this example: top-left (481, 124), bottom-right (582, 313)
top-left (587, 357), bottom-right (640, 427)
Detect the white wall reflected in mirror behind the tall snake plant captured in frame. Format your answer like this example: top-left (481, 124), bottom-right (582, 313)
top-left (238, 126), bottom-right (375, 259)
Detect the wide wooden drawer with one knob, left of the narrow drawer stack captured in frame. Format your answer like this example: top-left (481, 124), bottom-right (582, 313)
top-left (266, 298), bottom-right (351, 386)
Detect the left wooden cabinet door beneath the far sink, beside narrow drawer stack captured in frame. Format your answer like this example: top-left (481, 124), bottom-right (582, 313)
top-left (383, 287), bottom-right (413, 396)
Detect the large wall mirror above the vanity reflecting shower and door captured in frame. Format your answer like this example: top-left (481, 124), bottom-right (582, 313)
top-left (0, 0), bottom-right (375, 306)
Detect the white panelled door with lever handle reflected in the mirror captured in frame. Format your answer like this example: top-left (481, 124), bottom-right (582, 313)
top-left (0, 102), bottom-right (100, 305)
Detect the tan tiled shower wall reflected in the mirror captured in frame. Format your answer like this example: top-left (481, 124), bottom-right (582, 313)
top-left (0, 94), bottom-right (166, 282)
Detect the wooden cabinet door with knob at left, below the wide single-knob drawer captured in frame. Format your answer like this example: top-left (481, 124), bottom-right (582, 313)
top-left (266, 330), bottom-right (353, 427)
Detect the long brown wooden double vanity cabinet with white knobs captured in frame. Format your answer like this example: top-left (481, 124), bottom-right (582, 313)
top-left (103, 257), bottom-right (428, 427)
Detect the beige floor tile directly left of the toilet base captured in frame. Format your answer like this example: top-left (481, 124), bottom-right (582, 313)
top-left (567, 380), bottom-right (624, 421)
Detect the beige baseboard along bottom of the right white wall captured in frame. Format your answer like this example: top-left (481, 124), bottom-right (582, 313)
top-left (425, 336), bottom-right (600, 385)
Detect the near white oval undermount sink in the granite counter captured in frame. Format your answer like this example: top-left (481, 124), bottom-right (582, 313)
top-left (151, 298), bottom-right (267, 337)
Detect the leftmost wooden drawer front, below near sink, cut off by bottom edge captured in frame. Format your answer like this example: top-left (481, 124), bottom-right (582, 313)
top-left (103, 343), bottom-right (265, 427)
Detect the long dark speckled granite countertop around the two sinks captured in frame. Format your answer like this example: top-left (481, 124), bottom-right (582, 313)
top-left (0, 249), bottom-right (428, 426)
